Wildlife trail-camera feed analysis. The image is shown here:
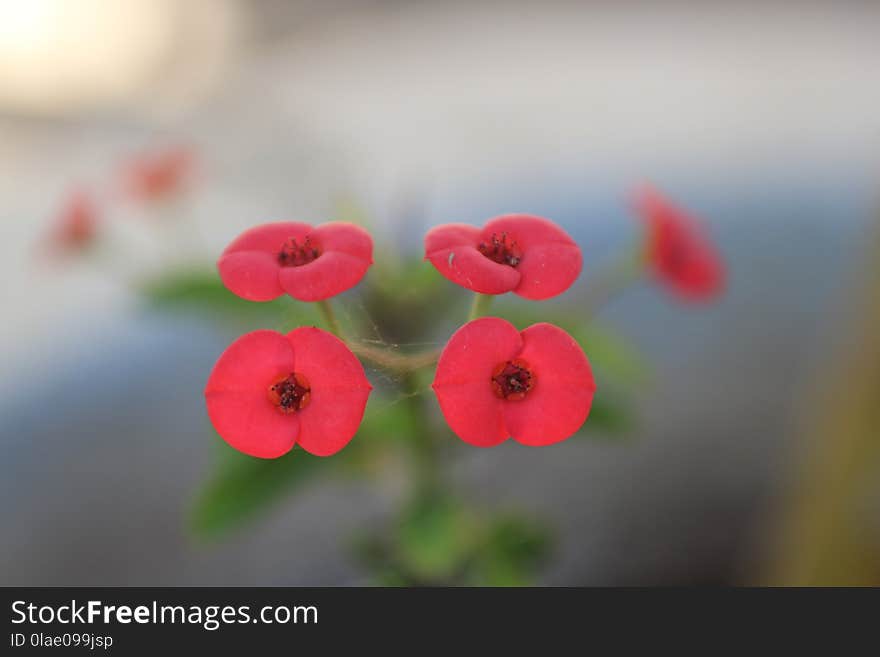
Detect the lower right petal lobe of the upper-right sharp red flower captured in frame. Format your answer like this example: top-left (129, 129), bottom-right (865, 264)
top-left (513, 242), bottom-right (582, 300)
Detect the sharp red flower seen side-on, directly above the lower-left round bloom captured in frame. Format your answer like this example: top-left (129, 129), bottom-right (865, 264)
top-left (217, 221), bottom-right (373, 301)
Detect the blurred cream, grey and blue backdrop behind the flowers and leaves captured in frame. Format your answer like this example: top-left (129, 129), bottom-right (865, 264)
top-left (0, 0), bottom-right (880, 585)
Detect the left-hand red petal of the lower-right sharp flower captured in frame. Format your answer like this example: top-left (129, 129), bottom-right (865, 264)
top-left (432, 317), bottom-right (522, 447)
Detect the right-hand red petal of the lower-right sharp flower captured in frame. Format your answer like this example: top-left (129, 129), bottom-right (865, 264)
top-left (503, 323), bottom-right (596, 446)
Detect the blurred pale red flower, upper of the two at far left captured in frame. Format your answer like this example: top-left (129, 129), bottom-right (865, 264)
top-left (123, 146), bottom-right (195, 201)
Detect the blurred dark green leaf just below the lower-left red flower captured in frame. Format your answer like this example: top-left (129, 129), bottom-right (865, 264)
top-left (190, 445), bottom-right (329, 538)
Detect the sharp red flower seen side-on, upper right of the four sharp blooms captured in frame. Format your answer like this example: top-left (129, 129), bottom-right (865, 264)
top-left (425, 214), bottom-right (581, 299)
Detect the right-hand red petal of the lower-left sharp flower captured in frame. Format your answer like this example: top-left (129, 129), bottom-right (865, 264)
top-left (287, 327), bottom-right (372, 456)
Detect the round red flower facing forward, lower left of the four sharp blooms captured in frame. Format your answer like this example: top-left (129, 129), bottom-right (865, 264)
top-left (205, 327), bottom-right (371, 458)
